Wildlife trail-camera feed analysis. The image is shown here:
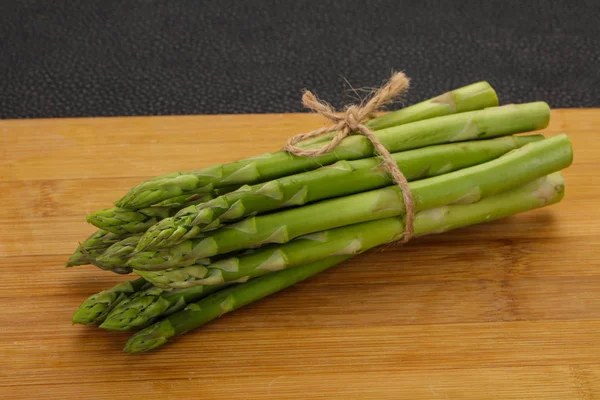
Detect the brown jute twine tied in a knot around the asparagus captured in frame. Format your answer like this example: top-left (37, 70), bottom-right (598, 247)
top-left (283, 72), bottom-right (415, 243)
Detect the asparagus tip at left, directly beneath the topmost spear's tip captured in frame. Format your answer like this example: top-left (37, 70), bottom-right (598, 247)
top-left (86, 193), bottom-right (214, 235)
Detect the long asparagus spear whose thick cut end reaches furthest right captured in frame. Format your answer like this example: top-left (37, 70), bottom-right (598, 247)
top-left (127, 135), bottom-right (572, 271)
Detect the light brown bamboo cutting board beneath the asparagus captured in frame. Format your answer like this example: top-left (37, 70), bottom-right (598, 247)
top-left (0, 110), bottom-right (600, 399)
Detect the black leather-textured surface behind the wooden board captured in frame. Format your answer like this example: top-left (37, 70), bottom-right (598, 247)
top-left (0, 0), bottom-right (600, 118)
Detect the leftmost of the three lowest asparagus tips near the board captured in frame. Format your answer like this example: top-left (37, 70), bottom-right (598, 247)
top-left (73, 278), bottom-right (149, 325)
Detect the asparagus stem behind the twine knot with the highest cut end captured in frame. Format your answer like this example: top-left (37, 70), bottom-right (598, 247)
top-left (300, 82), bottom-right (498, 146)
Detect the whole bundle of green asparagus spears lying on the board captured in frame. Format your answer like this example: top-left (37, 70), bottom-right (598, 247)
top-left (67, 78), bottom-right (572, 353)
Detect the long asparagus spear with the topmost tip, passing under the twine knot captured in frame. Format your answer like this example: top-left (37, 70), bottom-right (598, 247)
top-left (116, 102), bottom-right (550, 209)
